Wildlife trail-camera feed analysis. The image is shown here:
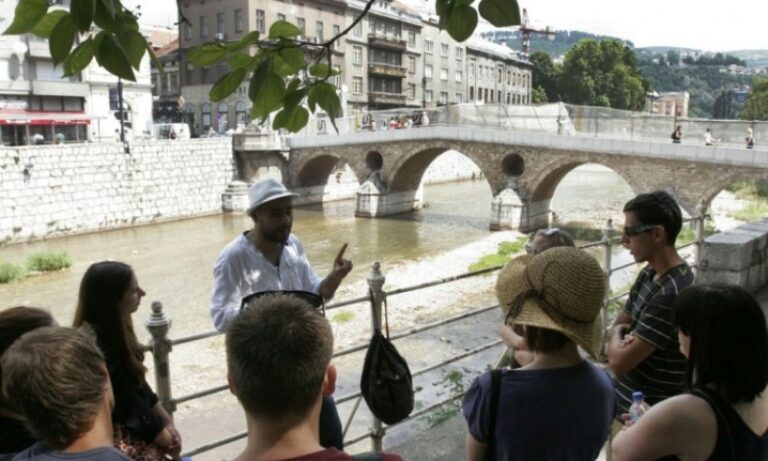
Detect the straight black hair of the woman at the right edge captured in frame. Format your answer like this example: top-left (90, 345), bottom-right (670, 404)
top-left (674, 285), bottom-right (768, 403)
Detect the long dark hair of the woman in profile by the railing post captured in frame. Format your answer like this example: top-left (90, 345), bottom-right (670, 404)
top-left (73, 261), bottom-right (147, 385)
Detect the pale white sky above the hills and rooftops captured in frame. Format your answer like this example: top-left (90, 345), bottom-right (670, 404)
top-left (135, 0), bottom-right (768, 51)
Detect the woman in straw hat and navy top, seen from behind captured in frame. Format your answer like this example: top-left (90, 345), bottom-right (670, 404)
top-left (463, 247), bottom-right (614, 461)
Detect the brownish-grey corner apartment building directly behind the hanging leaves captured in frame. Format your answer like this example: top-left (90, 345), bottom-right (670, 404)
top-left (179, 0), bottom-right (346, 135)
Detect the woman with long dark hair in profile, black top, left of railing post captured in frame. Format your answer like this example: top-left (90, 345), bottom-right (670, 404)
top-left (74, 261), bottom-right (181, 460)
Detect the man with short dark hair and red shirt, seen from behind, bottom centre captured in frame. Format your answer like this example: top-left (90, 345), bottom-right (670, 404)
top-left (226, 295), bottom-right (402, 461)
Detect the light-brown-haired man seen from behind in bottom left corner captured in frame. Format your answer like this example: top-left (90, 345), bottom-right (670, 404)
top-left (2, 327), bottom-right (130, 461)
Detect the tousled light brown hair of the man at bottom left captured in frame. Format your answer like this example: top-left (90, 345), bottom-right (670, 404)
top-left (2, 327), bottom-right (109, 449)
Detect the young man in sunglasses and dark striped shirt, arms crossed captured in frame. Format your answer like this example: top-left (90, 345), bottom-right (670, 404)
top-left (607, 191), bottom-right (694, 416)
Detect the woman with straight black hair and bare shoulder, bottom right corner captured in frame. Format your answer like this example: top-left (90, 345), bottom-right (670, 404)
top-left (613, 285), bottom-right (768, 461)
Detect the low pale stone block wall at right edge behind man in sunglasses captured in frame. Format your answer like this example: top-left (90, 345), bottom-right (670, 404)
top-left (698, 218), bottom-right (768, 293)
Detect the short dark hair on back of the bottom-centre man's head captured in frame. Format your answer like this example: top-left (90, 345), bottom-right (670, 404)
top-left (226, 295), bottom-right (333, 428)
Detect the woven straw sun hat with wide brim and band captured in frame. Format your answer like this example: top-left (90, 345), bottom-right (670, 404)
top-left (496, 247), bottom-right (605, 357)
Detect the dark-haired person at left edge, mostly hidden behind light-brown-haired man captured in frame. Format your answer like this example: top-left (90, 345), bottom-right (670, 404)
top-left (0, 306), bottom-right (56, 459)
